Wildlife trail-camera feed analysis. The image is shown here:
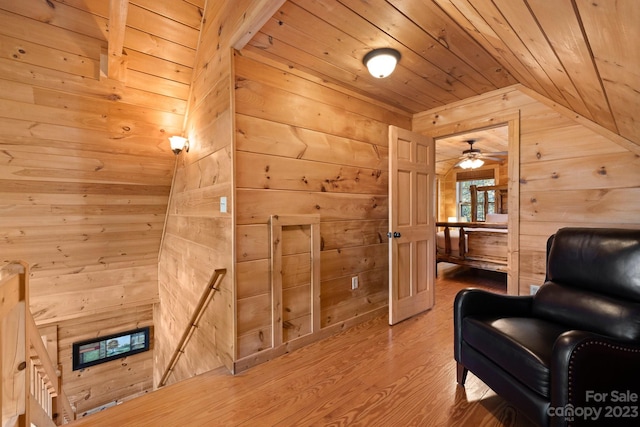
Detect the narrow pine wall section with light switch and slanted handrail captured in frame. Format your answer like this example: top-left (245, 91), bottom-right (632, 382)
top-left (154, 0), bottom-right (255, 384)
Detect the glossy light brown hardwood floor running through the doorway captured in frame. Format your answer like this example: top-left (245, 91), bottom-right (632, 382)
top-left (73, 267), bottom-right (533, 427)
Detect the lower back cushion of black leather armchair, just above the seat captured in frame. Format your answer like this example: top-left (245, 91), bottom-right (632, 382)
top-left (532, 282), bottom-right (640, 341)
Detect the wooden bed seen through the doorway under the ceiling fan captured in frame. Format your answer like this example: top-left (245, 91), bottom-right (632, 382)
top-left (436, 186), bottom-right (509, 272)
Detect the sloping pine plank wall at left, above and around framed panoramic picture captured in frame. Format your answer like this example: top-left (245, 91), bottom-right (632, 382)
top-left (0, 0), bottom-right (204, 410)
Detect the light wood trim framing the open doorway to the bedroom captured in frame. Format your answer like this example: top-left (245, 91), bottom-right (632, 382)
top-left (424, 109), bottom-right (520, 295)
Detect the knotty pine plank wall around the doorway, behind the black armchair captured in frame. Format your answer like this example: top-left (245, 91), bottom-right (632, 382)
top-left (413, 85), bottom-right (640, 294)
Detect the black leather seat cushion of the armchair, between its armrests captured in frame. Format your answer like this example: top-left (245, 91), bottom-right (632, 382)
top-left (462, 317), bottom-right (568, 397)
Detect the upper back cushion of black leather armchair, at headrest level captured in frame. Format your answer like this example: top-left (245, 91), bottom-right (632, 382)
top-left (547, 228), bottom-right (640, 302)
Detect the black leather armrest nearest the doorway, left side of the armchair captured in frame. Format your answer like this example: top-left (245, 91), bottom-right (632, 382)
top-left (453, 289), bottom-right (533, 362)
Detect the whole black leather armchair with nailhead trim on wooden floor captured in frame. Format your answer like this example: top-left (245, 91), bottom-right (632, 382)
top-left (454, 228), bottom-right (640, 426)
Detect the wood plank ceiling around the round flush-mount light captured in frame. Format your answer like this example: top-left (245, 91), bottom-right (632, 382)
top-left (245, 0), bottom-right (640, 144)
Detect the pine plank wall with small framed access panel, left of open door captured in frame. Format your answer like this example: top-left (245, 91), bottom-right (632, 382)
top-left (235, 49), bottom-right (410, 359)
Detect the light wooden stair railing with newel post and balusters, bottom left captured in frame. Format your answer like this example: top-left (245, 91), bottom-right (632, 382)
top-left (0, 262), bottom-right (75, 427)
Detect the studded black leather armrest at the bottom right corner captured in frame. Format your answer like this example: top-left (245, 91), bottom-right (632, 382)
top-left (551, 330), bottom-right (640, 426)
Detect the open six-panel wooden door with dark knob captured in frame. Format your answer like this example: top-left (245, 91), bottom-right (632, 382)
top-left (389, 126), bottom-right (436, 325)
